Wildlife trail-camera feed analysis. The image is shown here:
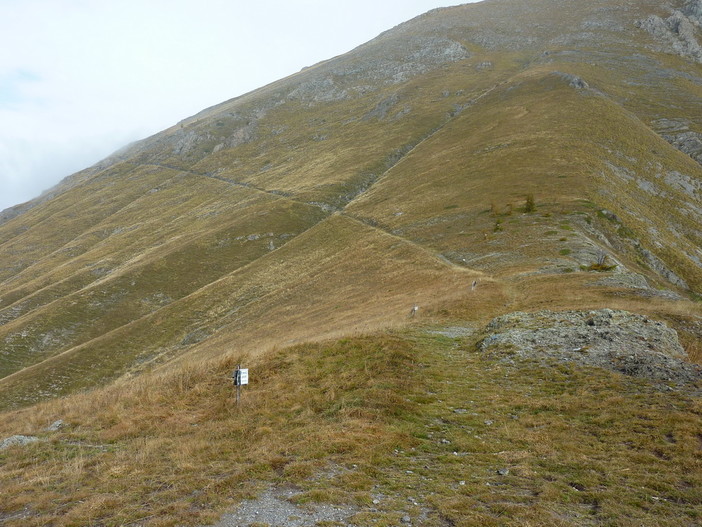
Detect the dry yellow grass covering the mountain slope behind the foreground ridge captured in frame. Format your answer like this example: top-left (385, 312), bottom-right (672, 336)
top-left (0, 14), bottom-right (700, 408)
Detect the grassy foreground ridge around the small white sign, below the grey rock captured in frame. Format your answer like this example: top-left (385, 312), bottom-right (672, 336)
top-left (0, 326), bottom-right (702, 526)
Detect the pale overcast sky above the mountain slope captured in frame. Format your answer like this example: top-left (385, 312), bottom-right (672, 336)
top-left (0, 0), bottom-right (484, 210)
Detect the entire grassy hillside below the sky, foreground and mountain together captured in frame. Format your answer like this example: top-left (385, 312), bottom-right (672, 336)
top-left (0, 0), bottom-right (702, 526)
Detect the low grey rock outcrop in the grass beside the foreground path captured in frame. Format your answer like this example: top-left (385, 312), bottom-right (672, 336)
top-left (478, 309), bottom-right (702, 383)
